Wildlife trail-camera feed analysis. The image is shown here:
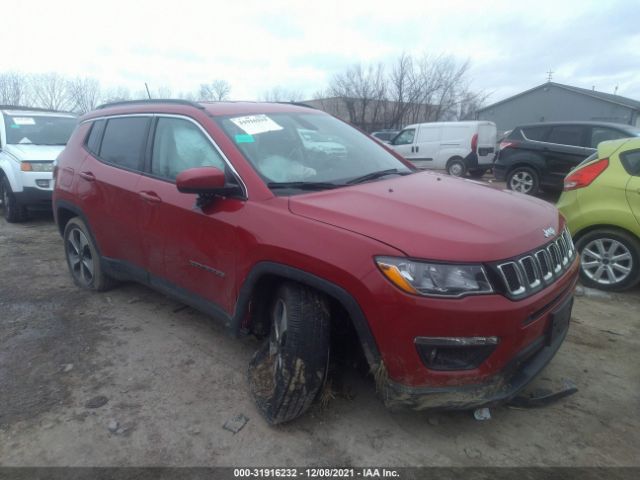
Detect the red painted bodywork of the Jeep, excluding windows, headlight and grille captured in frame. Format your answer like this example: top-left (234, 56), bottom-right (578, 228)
top-left (54, 103), bottom-right (577, 404)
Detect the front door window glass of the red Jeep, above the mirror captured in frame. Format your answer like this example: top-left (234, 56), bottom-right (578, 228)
top-left (151, 118), bottom-right (225, 180)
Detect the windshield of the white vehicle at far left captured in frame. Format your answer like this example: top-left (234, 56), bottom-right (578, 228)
top-left (4, 112), bottom-right (76, 145)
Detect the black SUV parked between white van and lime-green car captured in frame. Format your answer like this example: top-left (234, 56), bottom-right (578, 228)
top-left (493, 122), bottom-right (640, 195)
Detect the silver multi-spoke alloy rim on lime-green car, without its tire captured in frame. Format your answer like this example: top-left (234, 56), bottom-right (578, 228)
top-left (580, 238), bottom-right (633, 285)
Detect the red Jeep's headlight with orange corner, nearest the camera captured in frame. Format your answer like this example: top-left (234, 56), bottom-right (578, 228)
top-left (375, 257), bottom-right (493, 297)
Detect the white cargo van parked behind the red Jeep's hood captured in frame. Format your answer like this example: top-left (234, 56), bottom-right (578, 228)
top-left (390, 121), bottom-right (497, 177)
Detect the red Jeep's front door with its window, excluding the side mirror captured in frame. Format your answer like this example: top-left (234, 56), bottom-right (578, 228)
top-left (138, 115), bottom-right (244, 314)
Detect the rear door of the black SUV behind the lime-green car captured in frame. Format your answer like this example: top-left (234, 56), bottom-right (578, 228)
top-left (541, 124), bottom-right (592, 186)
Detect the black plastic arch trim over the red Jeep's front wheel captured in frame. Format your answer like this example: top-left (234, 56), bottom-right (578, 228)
top-left (230, 261), bottom-right (381, 371)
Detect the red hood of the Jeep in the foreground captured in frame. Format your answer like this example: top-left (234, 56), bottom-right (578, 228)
top-left (289, 172), bottom-right (562, 262)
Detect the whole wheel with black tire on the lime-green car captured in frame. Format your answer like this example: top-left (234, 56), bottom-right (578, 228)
top-left (576, 228), bottom-right (640, 292)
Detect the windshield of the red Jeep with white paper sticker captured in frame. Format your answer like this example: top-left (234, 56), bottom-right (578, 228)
top-left (217, 113), bottom-right (412, 188)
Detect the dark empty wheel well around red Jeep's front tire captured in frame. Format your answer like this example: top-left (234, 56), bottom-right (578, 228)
top-left (247, 274), bottom-right (373, 368)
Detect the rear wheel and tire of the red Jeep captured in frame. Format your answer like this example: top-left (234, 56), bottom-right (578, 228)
top-left (63, 217), bottom-right (117, 292)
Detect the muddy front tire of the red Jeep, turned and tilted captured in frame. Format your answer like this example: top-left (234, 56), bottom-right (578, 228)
top-left (249, 282), bottom-right (329, 425)
